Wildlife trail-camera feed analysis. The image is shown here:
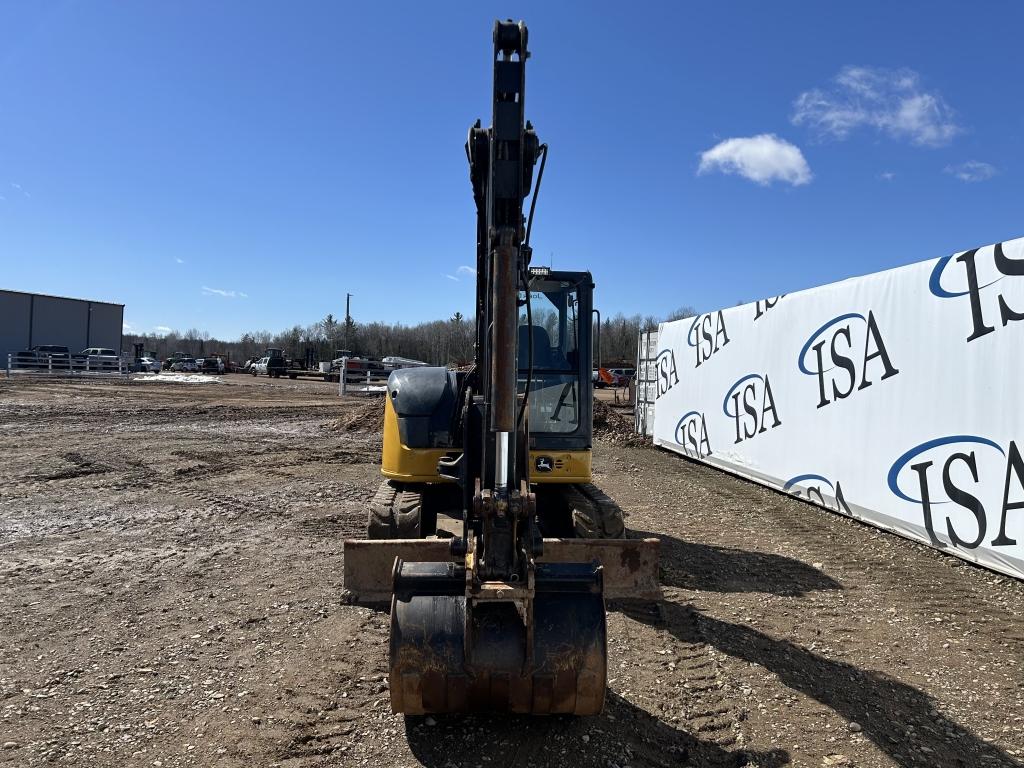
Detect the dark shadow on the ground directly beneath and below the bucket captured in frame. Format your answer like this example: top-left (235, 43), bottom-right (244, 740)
top-left (406, 691), bottom-right (790, 768)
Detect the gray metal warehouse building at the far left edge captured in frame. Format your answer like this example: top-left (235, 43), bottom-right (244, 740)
top-left (0, 290), bottom-right (125, 365)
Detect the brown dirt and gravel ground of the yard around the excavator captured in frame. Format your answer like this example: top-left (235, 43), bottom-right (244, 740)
top-left (0, 376), bottom-right (1024, 768)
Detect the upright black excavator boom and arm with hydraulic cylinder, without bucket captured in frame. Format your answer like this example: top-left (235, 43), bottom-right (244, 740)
top-left (459, 22), bottom-right (541, 594)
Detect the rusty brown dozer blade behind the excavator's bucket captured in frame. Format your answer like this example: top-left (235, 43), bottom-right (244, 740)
top-left (343, 539), bottom-right (662, 604)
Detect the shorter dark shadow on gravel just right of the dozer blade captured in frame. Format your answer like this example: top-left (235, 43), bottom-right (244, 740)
top-left (630, 530), bottom-right (843, 597)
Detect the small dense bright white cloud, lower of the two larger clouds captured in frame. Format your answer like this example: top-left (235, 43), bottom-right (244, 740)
top-left (697, 133), bottom-right (812, 186)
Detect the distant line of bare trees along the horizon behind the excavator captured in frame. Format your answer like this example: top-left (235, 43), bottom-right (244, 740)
top-left (123, 307), bottom-right (695, 367)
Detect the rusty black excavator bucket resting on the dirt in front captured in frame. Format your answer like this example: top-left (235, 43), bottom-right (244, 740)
top-left (389, 561), bottom-right (607, 715)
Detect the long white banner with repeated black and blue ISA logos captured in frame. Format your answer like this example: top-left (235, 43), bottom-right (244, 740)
top-left (654, 239), bottom-right (1024, 579)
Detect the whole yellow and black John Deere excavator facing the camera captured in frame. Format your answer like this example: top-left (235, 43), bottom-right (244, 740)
top-left (344, 20), bottom-right (658, 715)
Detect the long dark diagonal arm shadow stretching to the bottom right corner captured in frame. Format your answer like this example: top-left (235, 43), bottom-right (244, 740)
top-left (626, 601), bottom-right (1021, 768)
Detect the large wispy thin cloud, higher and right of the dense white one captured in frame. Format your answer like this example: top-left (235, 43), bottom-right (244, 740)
top-left (793, 67), bottom-right (962, 146)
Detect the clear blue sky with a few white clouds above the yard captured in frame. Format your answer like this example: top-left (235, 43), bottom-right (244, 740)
top-left (0, 0), bottom-right (1024, 337)
